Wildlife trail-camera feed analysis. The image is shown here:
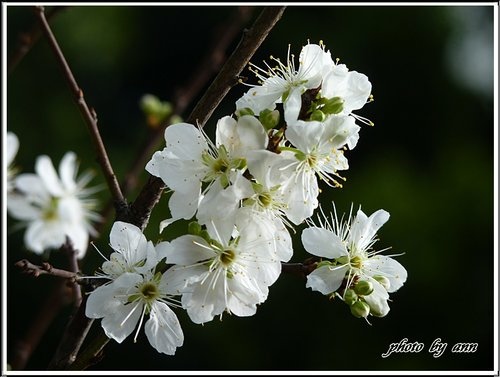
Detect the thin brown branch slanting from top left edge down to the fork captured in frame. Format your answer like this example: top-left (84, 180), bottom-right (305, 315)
top-left (35, 6), bottom-right (128, 217)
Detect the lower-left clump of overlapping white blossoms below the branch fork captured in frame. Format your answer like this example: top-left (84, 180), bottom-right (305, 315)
top-left (85, 221), bottom-right (184, 355)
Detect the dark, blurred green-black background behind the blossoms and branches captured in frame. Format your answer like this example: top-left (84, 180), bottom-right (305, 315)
top-left (3, 4), bottom-right (498, 371)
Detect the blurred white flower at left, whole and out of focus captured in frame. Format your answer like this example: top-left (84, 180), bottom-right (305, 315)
top-left (7, 152), bottom-right (100, 258)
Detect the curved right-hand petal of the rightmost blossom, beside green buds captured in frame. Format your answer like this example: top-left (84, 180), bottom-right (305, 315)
top-left (363, 255), bottom-right (408, 293)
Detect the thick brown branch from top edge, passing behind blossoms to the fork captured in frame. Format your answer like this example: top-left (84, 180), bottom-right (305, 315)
top-left (127, 7), bottom-right (286, 229)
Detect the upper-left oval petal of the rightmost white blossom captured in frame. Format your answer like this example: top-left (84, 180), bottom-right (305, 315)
top-left (302, 227), bottom-right (348, 259)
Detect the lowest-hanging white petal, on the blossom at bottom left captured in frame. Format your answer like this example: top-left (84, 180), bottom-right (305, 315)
top-left (144, 302), bottom-right (184, 355)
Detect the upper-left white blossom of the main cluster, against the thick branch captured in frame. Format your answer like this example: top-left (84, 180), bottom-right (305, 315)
top-left (146, 116), bottom-right (268, 229)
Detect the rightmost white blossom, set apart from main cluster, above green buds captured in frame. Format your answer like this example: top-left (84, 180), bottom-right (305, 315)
top-left (302, 204), bottom-right (407, 316)
